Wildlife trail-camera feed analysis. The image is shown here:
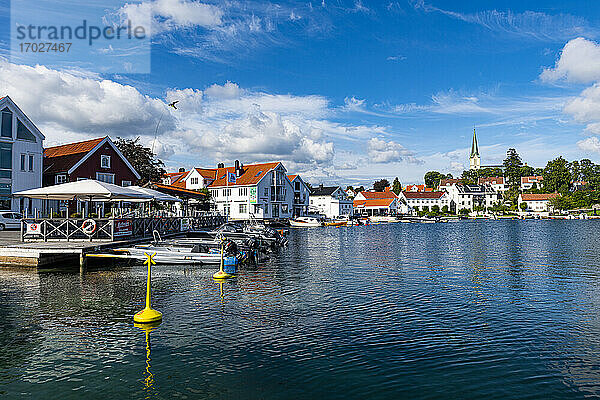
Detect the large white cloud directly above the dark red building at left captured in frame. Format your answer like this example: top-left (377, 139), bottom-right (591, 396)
top-left (0, 62), bottom-right (174, 141)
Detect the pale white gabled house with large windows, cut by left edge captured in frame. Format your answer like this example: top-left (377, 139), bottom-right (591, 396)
top-left (0, 96), bottom-right (45, 213)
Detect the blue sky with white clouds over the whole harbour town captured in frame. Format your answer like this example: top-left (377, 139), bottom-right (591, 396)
top-left (0, 0), bottom-right (600, 184)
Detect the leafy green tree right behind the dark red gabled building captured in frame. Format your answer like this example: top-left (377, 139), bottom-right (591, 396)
top-left (115, 136), bottom-right (166, 184)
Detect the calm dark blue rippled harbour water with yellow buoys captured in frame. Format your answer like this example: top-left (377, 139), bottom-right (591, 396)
top-left (0, 221), bottom-right (600, 400)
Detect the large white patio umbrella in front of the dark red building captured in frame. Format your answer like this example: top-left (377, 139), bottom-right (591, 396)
top-left (13, 179), bottom-right (153, 201)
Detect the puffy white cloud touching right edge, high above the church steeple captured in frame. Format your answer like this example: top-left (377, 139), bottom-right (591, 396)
top-left (540, 37), bottom-right (600, 83)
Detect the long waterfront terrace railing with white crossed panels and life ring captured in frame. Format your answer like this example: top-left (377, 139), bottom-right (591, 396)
top-left (21, 215), bottom-right (227, 242)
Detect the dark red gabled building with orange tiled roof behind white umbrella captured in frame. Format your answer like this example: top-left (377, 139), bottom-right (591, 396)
top-left (43, 136), bottom-right (140, 213)
